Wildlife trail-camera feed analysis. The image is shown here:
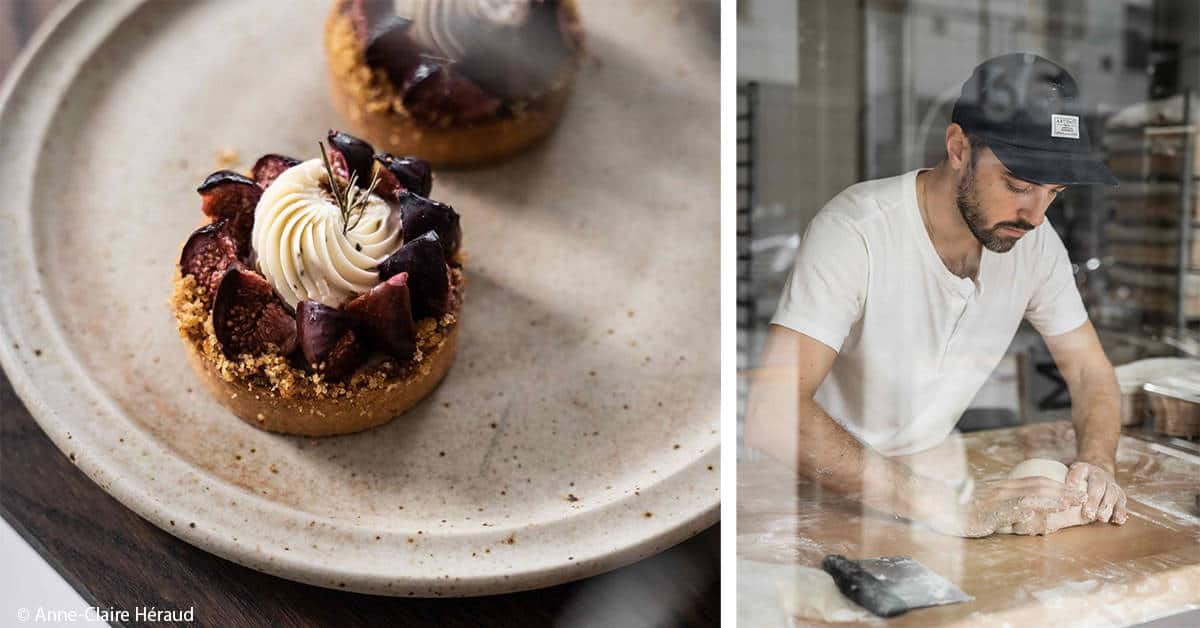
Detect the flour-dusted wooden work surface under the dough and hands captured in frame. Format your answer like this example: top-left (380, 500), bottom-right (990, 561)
top-left (738, 421), bottom-right (1200, 628)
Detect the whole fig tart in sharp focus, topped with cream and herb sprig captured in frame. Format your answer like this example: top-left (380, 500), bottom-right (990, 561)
top-left (172, 131), bottom-right (466, 436)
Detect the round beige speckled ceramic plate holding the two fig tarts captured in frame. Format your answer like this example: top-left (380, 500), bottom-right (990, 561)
top-left (0, 0), bottom-right (720, 596)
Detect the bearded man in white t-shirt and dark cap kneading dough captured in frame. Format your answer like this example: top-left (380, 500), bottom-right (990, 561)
top-left (744, 54), bottom-right (1128, 537)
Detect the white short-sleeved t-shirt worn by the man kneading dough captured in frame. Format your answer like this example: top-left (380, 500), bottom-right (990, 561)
top-left (772, 171), bottom-right (1087, 455)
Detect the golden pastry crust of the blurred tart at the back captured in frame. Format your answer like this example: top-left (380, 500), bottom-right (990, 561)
top-left (325, 0), bottom-right (581, 167)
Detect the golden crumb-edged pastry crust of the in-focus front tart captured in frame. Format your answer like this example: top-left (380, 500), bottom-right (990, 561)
top-left (170, 262), bottom-right (466, 436)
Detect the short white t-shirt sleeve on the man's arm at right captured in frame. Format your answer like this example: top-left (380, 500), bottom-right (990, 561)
top-left (1025, 223), bottom-right (1087, 336)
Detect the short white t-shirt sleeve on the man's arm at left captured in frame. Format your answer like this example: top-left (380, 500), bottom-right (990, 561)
top-left (770, 214), bottom-right (868, 351)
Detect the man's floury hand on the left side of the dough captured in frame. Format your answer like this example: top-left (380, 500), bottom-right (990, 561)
top-left (925, 478), bottom-right (1087, 538)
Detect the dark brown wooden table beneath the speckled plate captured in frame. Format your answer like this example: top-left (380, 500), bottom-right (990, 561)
top-left (0, 0), bottom-right (721, 627)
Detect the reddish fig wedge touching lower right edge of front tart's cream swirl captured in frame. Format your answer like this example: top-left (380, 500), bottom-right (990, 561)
top-left (346, 273), bottom-right (416, 363)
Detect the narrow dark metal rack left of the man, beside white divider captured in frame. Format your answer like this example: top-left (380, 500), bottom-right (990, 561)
top-left (737, 82), bottom-right (758, 417)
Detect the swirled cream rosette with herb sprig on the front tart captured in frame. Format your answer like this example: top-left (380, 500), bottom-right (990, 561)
top-left (251, 159), bottom-right (402, 307)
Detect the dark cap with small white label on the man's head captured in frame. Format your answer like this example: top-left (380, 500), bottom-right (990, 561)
top-left (950, 53), bottom-right (1117, 185)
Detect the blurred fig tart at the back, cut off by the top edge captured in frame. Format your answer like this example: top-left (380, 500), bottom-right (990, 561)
top-left (325, 0), bottom-right (583, 166)
